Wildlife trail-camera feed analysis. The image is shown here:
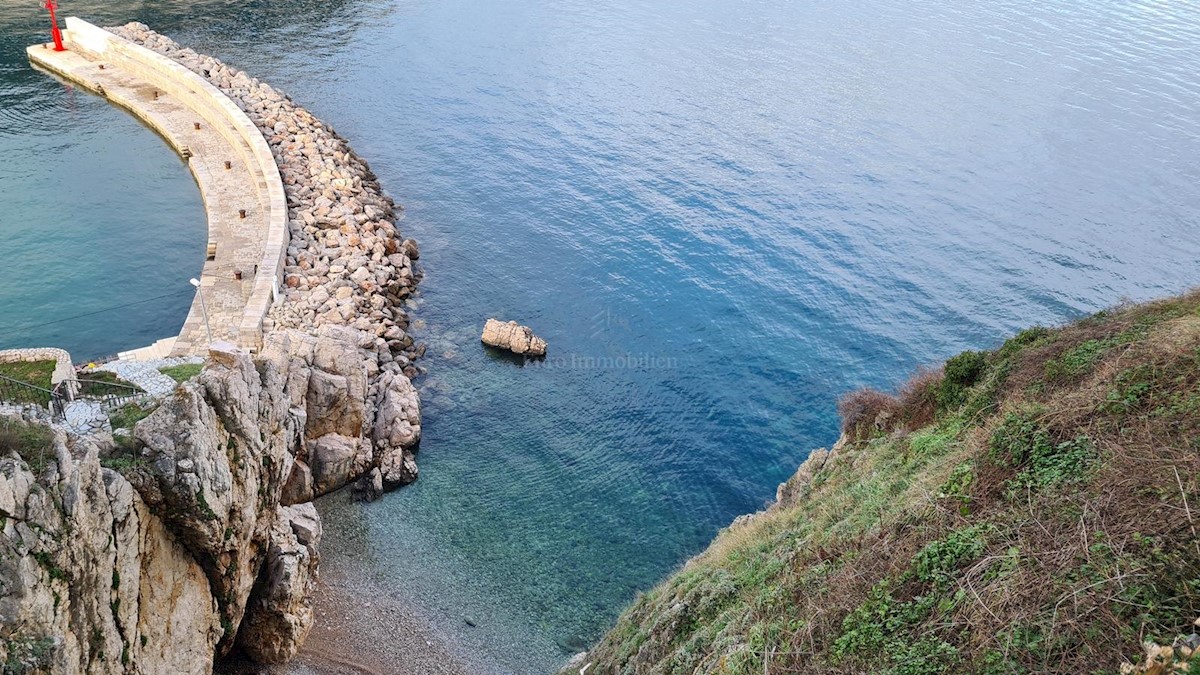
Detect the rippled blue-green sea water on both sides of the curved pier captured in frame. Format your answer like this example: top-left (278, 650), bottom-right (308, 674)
top-left (0, 0), bottom-right (1200, 673)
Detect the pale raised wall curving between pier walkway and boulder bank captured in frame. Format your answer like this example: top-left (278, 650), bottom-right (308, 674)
top-left (66, 17), bottom-right (288, 350)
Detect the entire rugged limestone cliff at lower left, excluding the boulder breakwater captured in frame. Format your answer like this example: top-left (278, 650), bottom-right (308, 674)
top-left (0, 339), bottom-right (334, 673)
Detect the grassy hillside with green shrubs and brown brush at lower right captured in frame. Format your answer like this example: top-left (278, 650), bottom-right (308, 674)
top-left (588, 293), bottom-right (1200, 675)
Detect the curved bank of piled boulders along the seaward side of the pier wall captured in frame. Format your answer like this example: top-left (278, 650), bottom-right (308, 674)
top-left (107, 23), bottom-right (425, 497)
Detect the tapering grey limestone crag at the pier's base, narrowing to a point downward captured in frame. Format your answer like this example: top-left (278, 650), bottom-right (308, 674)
top-left (133, 342), bottom-right (290, 653)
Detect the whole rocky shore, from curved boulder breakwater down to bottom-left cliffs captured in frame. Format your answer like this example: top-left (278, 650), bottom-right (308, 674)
top-left (0, 23), bottom-right (424, 673)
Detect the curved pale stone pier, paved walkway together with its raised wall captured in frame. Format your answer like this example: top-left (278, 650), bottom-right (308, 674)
top-left (28, 18), bottom-right (287, 357)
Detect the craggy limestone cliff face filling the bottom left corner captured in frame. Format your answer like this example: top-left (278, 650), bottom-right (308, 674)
top-left (0, 415), bottom-right (223, 674)
